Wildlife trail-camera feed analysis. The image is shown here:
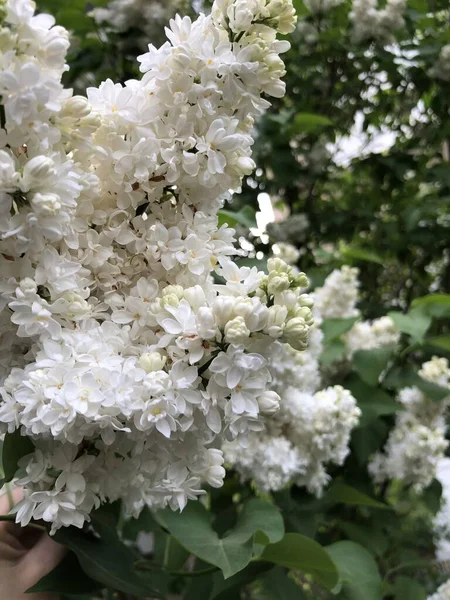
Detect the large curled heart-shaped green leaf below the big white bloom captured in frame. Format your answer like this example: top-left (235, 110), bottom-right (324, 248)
top-left (155, 499), bottom-right (284, 579)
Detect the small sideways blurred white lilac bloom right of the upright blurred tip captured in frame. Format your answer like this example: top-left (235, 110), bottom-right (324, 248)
top-left (345, 317), bottom-right (401, 358)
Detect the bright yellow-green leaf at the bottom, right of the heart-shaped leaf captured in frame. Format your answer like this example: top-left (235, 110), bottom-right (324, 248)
top-left (261, 533), bottom-right (339, 590)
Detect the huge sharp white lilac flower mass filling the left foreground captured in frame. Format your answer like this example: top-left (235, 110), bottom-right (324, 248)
top-left (0, 0), bottom-right (313, 531)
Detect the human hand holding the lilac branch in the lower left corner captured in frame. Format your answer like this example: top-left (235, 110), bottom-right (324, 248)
top-left (0, 489), bottom-right (65, 600)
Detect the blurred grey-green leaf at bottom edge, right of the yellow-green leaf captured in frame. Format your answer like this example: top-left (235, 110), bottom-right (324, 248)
top-left (326, 541), bottom-right (384, 600)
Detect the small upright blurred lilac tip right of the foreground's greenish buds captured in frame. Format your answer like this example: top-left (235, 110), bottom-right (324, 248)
top-left (313, 265), bottom-right (360, 322)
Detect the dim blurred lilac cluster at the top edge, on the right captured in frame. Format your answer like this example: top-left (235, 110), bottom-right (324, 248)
top-left (350, 0), bottom-right (407, 43)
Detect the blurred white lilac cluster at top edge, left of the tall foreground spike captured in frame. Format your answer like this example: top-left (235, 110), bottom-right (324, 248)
top-left (90, 0), bottom-right (189, 43)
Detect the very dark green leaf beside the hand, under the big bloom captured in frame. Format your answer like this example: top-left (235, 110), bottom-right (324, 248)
top-left (55, 509), bottom-right (161, 598)
